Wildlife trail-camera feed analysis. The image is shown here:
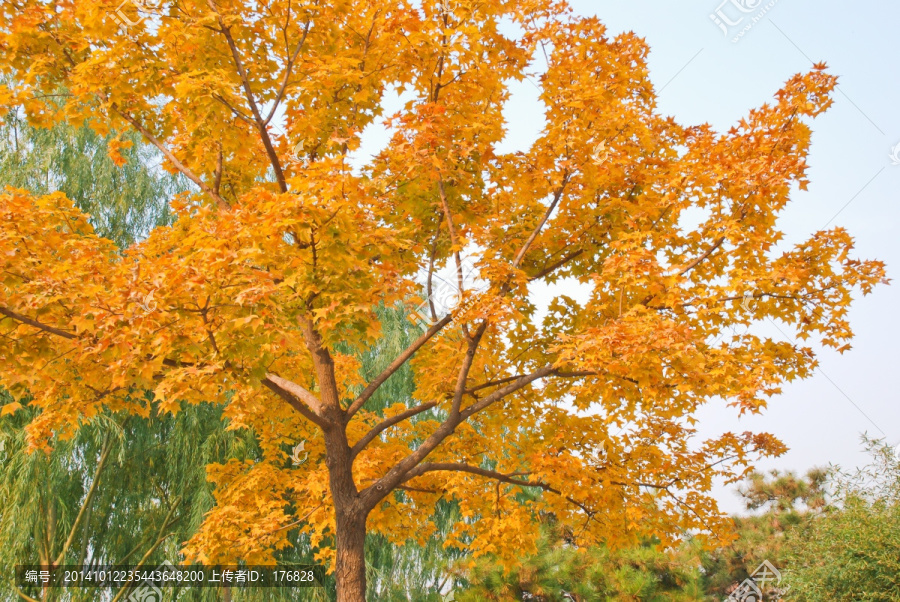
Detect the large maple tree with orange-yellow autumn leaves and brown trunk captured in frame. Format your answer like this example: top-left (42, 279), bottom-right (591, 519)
top-left (0, 0), bottom-right (884, 601)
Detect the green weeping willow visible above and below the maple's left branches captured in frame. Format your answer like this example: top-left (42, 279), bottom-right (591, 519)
top-left (0, 111), bottom-right (333, 601)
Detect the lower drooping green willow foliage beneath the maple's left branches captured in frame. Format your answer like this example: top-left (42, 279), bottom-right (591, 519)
top-left (0, 404), bottom-right (255, 601)
